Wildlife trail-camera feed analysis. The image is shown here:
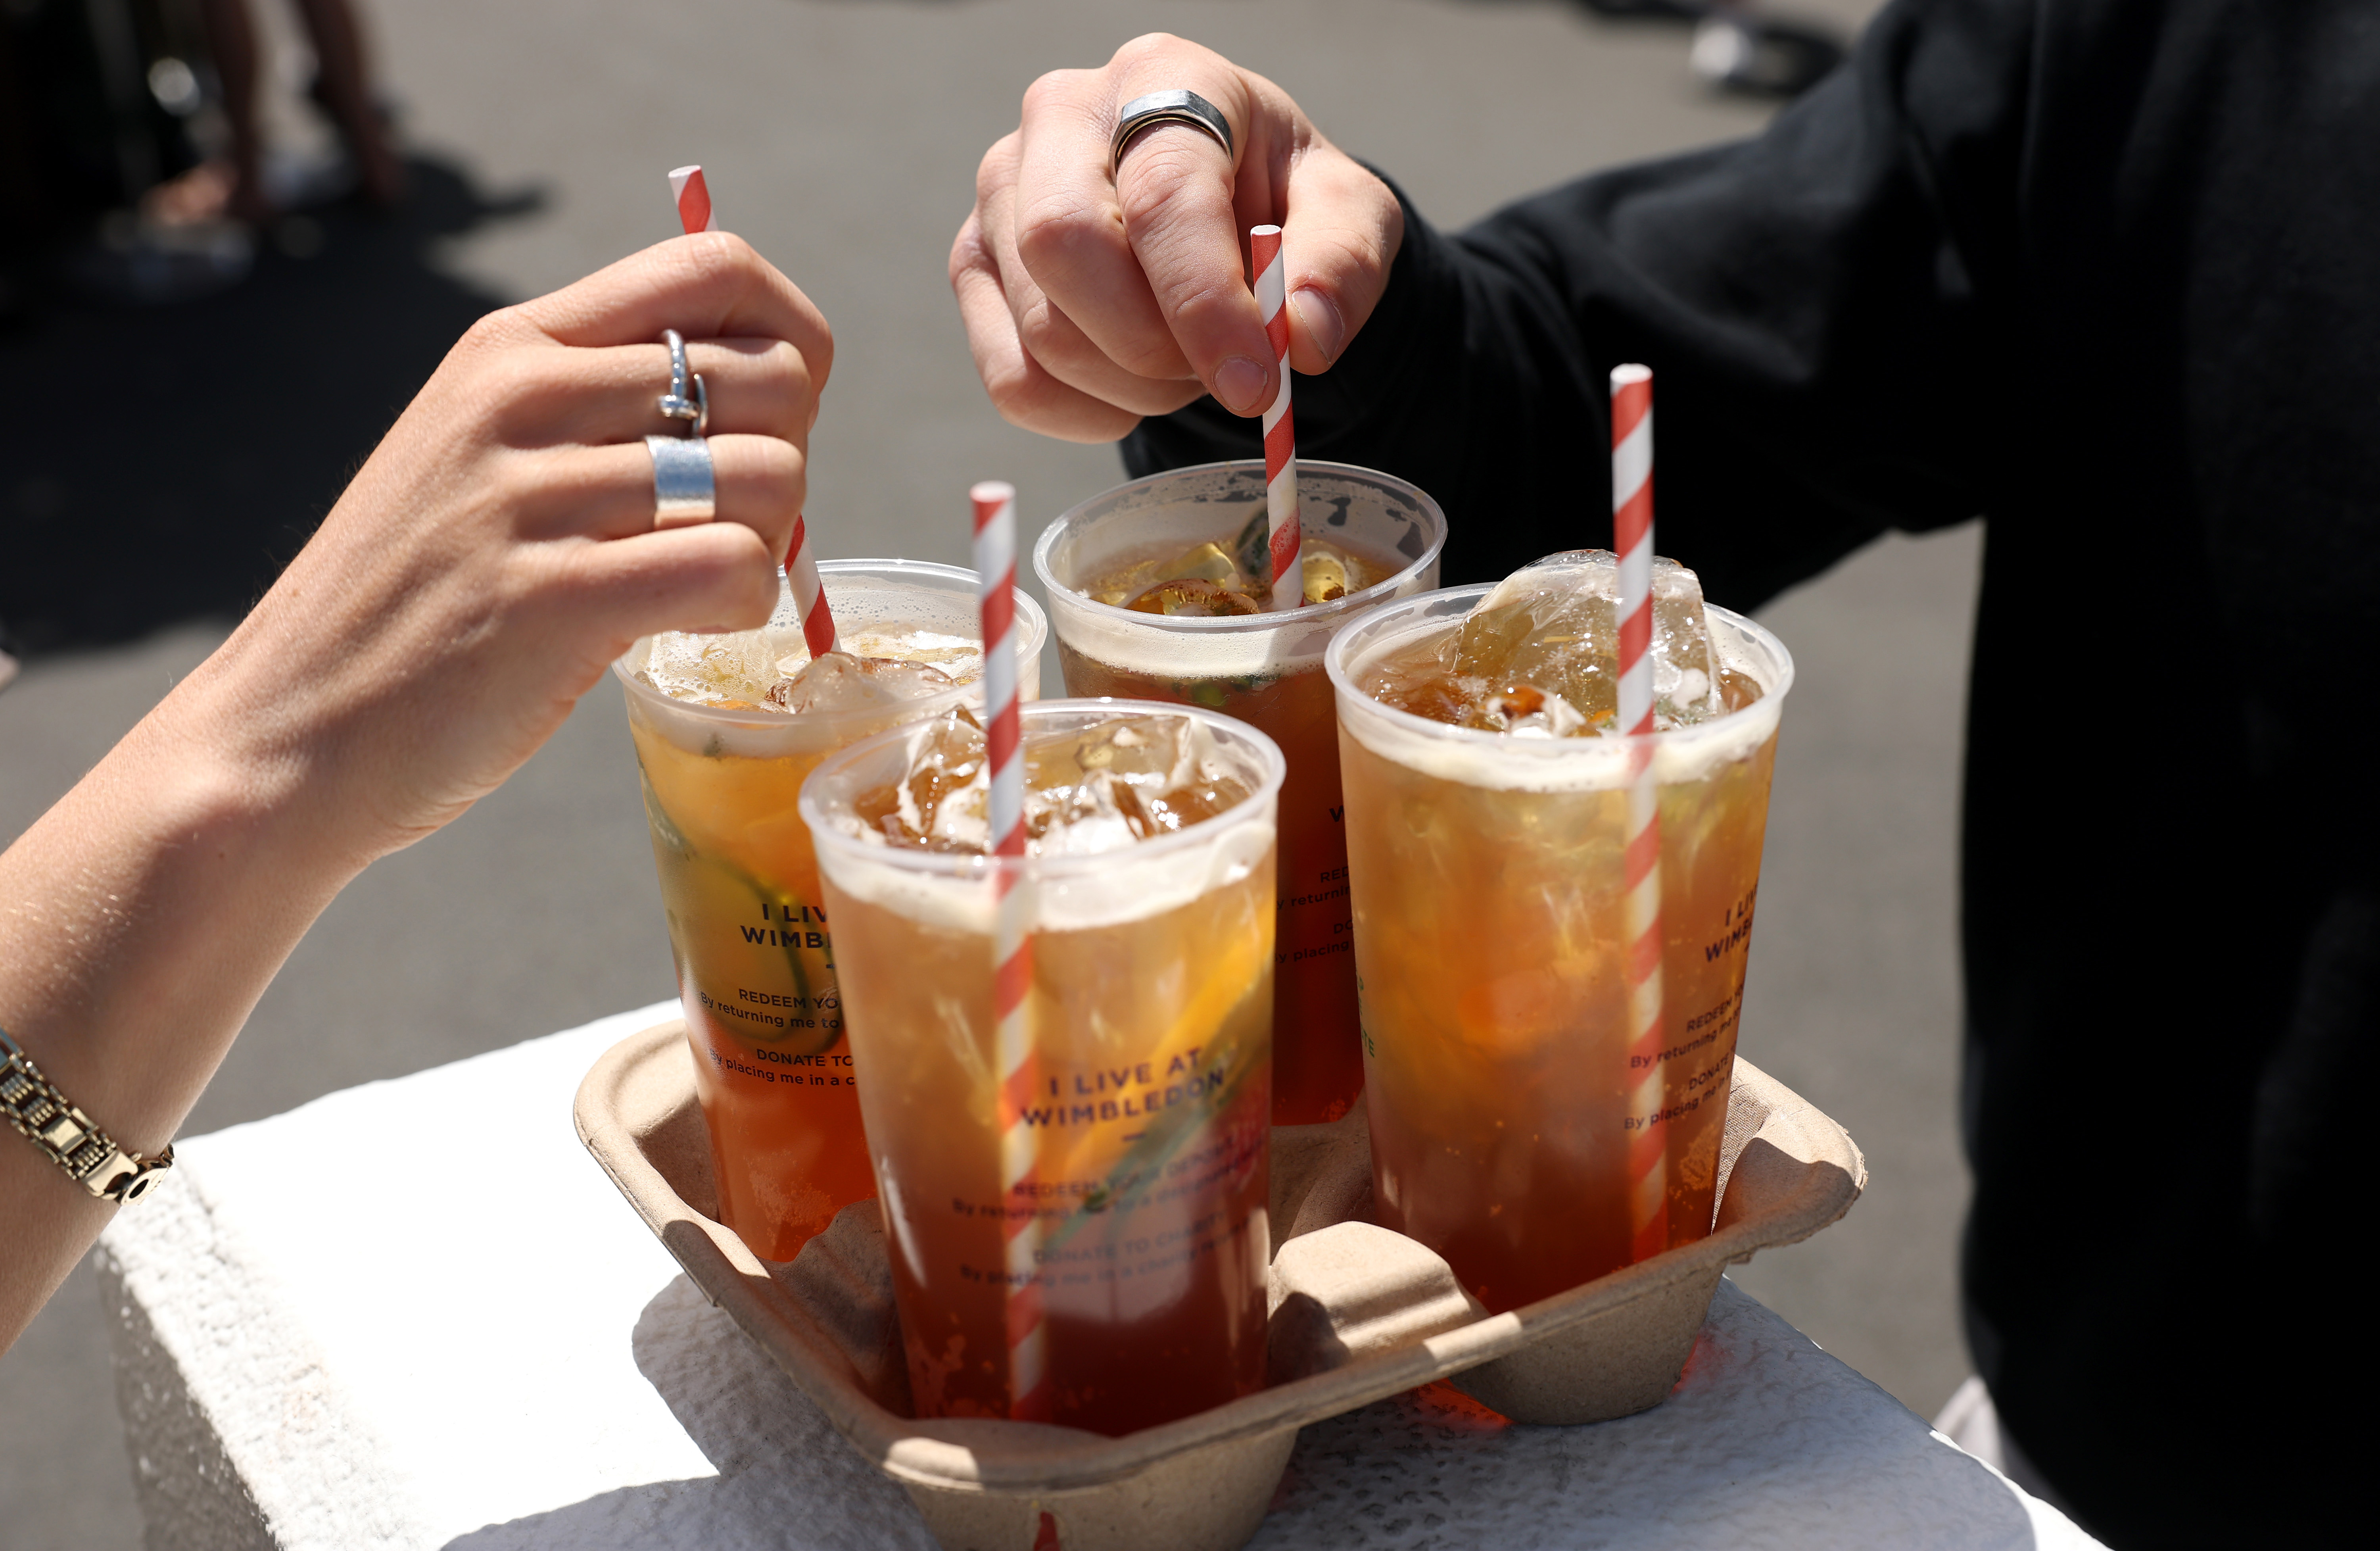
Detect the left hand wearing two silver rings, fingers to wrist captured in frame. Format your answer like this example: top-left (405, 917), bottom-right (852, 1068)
top-left (178, 233), bottom-right (833, 868)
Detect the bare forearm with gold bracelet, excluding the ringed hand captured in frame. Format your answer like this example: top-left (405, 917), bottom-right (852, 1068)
top-left (0, 669), bottom-right (362, 1349)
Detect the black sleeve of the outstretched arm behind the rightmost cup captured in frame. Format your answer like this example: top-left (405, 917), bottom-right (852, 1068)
top-left (1123, 0), bottom-right (2033, 609)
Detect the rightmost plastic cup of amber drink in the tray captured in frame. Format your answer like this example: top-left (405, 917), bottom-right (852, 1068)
top-left (1328, 588), bottom-right (1792, 1311)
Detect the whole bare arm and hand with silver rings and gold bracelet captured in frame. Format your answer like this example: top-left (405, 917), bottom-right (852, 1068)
top-left (0, 233), bottom-right (833, 1351)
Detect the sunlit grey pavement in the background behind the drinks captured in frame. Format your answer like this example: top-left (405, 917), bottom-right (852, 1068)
top-left (0, 0), bottom-right (1978, 1551)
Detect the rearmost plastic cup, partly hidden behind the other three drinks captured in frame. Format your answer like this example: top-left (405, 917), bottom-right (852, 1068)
top-left (1033, 459), bottom-right (1447, 1125)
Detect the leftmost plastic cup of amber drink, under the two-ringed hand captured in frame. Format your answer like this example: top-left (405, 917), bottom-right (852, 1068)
top-left (612, 559), bottom-right (1050, 1261)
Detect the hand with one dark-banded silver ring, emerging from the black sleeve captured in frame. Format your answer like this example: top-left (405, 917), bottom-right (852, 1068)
top-left (950, 33), bottom-right (1404, 442)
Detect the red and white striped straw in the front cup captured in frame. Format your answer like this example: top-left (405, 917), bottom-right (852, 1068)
top-left (966, 480), bottom-right (1050, 1420)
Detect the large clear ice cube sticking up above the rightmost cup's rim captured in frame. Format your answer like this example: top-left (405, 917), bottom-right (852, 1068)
top-left (1454, 550), bottom-right (1726, 738)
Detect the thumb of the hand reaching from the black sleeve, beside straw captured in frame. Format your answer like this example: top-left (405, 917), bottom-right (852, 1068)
top-left (1280, 145), bottom-right (1404, 376)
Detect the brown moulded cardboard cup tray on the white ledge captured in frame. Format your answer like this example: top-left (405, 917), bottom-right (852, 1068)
top-left (576, 1018), bottom-right (1868, 1551)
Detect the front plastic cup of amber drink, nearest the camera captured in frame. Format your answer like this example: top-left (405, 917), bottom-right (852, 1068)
top-left (802, 700), bottom-right (1283, 1434)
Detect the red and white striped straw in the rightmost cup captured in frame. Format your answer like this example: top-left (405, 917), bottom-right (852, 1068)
top-left (1611, 366), bottom-right (1668, 1261)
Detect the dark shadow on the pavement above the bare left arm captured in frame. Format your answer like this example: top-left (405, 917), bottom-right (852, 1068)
top-left (0, 160), bottom-right (545, 654)
